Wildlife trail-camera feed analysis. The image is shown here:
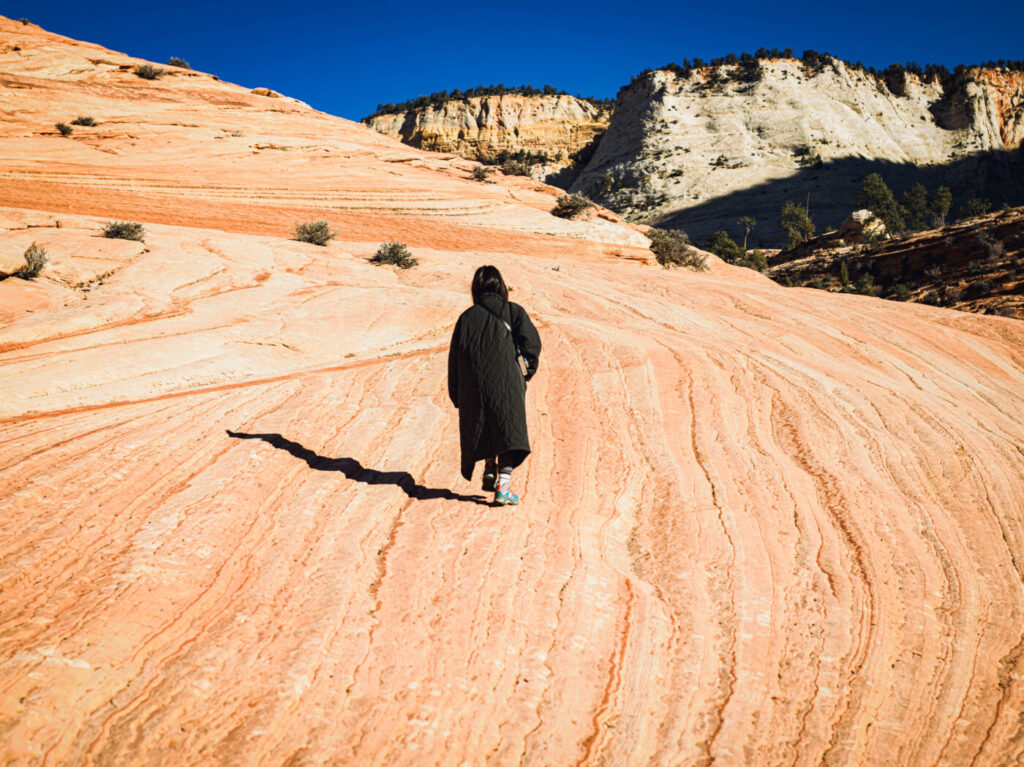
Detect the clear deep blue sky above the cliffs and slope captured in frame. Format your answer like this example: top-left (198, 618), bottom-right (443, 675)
top-left (9, 0), bottom-right (1024, 120)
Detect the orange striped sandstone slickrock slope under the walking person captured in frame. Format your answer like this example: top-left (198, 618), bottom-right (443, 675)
top-left (0, 13), bottom-right (1024, 765)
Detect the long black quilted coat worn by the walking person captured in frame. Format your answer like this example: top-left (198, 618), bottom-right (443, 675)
top-left (449, 293), bottom-right (541, 479)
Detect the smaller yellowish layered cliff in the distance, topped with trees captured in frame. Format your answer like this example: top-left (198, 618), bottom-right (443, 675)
top-left (364, 94), bottom-right (611, 164)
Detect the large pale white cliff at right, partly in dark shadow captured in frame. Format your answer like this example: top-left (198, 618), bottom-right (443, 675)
top-left (572, 59), bottom-right (1024, 244)
